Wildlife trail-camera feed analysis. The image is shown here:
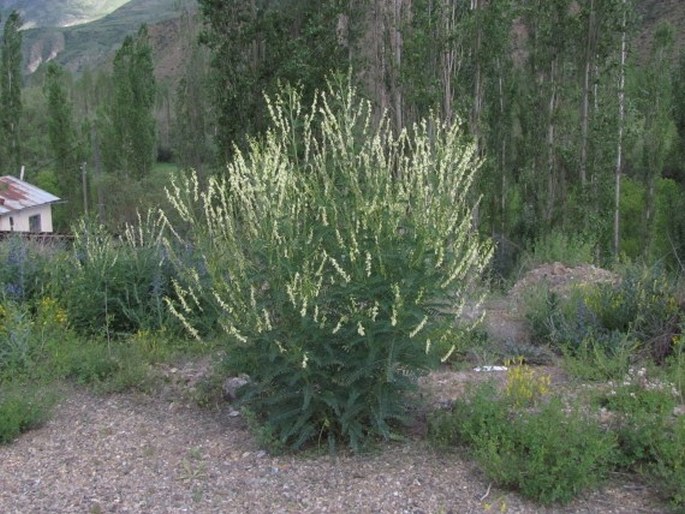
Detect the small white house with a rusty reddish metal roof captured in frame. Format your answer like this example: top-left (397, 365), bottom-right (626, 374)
top-left (0, 175), bottom-right (60, 232)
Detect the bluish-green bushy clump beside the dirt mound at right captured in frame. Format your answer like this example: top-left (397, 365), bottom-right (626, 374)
top-left (526, 266), bottom-right (683, 366)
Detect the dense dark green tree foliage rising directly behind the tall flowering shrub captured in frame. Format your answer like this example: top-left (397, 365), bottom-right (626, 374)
top-left (199, 0), bottom-right (350, 158)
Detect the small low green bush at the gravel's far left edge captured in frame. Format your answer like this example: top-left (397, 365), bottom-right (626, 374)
top-left (0, 383), bottom-right (56, 444)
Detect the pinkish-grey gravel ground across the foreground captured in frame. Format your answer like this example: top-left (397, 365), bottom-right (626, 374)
top-left (0, 384), bottom-right (665, 514)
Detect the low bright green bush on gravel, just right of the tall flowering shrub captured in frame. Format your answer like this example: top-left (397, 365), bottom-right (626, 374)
top-left (430, 385), bottom-right (616, 504)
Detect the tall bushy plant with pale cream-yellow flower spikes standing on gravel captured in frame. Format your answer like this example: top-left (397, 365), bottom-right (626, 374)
top-left (161, 83), bottom-right (491, 449)
